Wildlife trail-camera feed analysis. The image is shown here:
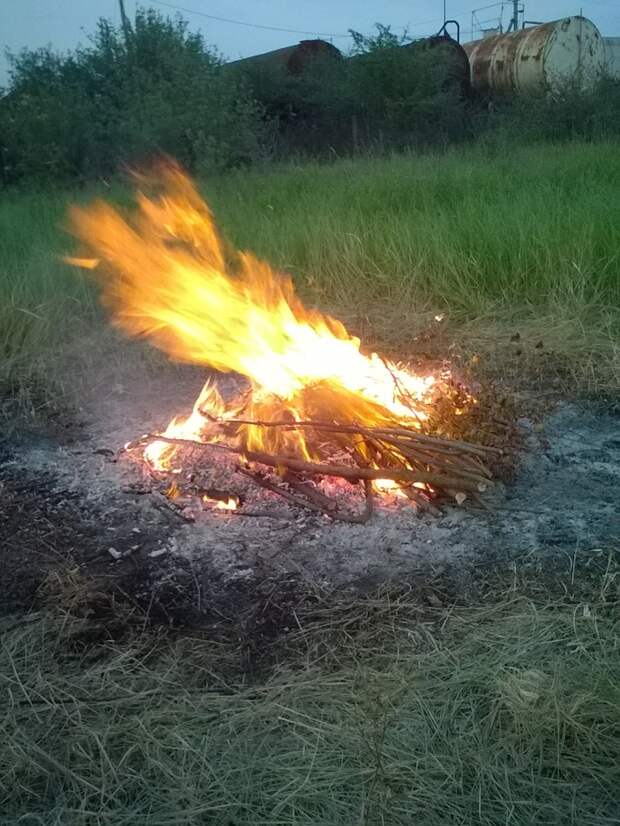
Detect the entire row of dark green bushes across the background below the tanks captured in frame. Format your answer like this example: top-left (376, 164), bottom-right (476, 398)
top-left (0, 10), bottom-right (620, 183)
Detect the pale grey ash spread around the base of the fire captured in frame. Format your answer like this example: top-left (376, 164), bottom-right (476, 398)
top-left (0, 370), bottom-right (620, 601)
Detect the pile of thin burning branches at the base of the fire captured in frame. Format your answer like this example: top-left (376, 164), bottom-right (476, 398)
top-left (134, 419), bottom-right (502, 522)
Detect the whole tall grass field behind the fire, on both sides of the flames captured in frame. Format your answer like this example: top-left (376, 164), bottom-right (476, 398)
top-left (0, 144), bottom-right (620, 418)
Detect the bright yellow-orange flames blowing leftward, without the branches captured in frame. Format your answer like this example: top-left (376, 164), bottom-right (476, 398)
top-left (66, 163), bottom-right (464, 507)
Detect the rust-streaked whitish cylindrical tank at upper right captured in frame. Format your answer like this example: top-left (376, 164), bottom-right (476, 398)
top-left (464, 16), bottom-right (605, 93)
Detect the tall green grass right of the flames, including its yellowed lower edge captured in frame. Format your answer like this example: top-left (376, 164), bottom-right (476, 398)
top-left (205, 144), bottom-right (620, 389)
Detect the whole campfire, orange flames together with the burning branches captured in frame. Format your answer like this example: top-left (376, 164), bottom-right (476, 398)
top-left (68, 163), bottom-right (496, 522)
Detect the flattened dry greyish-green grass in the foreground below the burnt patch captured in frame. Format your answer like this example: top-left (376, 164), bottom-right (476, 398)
top-left (0, 551), bottom-right (620, 826)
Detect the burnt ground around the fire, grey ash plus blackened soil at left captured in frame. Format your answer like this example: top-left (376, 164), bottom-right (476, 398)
top-left (0, 362), bottom-right (620, 633)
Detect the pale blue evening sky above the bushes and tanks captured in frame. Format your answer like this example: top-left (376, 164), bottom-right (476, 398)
top-left (0, 0), bottom-right (620, 86)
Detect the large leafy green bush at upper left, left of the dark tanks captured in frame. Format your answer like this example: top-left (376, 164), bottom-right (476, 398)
top-left (0, 10), bottom-right (264, 181)
